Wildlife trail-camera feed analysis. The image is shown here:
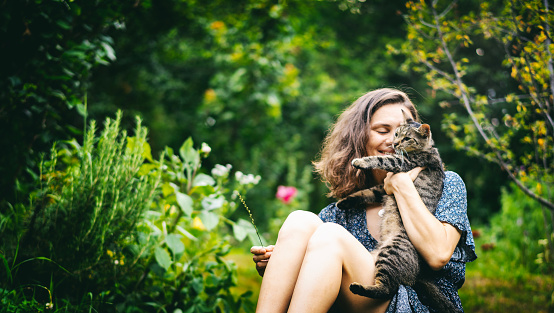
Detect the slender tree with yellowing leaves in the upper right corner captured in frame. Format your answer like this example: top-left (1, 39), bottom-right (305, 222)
top-left (391, 0), bottom-right (554, 251)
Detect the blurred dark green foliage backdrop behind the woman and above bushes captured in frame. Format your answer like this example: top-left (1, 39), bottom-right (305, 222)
top-left (0, 0), bottom-right (503, 227)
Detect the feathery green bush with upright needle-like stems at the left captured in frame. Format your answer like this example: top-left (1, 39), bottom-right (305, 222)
top-left (0, 112), bottom-right (159, 303)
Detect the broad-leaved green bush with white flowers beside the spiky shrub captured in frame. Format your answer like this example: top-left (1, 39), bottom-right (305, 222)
top-left (106, 138), bottom-right (260, 312)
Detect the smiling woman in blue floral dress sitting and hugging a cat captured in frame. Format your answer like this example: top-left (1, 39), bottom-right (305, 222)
top-left (251, 88), bottom-right (476, 313)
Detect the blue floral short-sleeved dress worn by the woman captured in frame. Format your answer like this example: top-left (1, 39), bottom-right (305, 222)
top-left (319, 171), bottom-right (477, 313)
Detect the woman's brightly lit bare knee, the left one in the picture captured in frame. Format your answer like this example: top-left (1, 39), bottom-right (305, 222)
top-left (279, 210), bottom-right (323, 240)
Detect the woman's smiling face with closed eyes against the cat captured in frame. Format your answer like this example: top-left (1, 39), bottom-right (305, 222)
top-left (366, 104), bottom-right (413, 182)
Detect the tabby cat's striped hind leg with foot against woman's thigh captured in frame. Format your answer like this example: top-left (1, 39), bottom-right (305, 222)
top-left (350, 236), bottom-right (419, 299)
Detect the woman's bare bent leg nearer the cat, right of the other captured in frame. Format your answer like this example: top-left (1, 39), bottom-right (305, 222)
top-left (289, 223), bottom-right (389, 312)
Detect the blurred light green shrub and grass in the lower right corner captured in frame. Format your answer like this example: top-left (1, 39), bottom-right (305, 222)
top-left (460, 184), bottom-right (554, 312)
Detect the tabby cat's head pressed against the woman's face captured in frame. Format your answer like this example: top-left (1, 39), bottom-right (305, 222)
top-left (392, 110), bottom-right (434, 153)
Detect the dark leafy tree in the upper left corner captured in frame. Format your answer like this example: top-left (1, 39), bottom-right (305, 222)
top-left (0, 0), bottom-right (138, 206)
